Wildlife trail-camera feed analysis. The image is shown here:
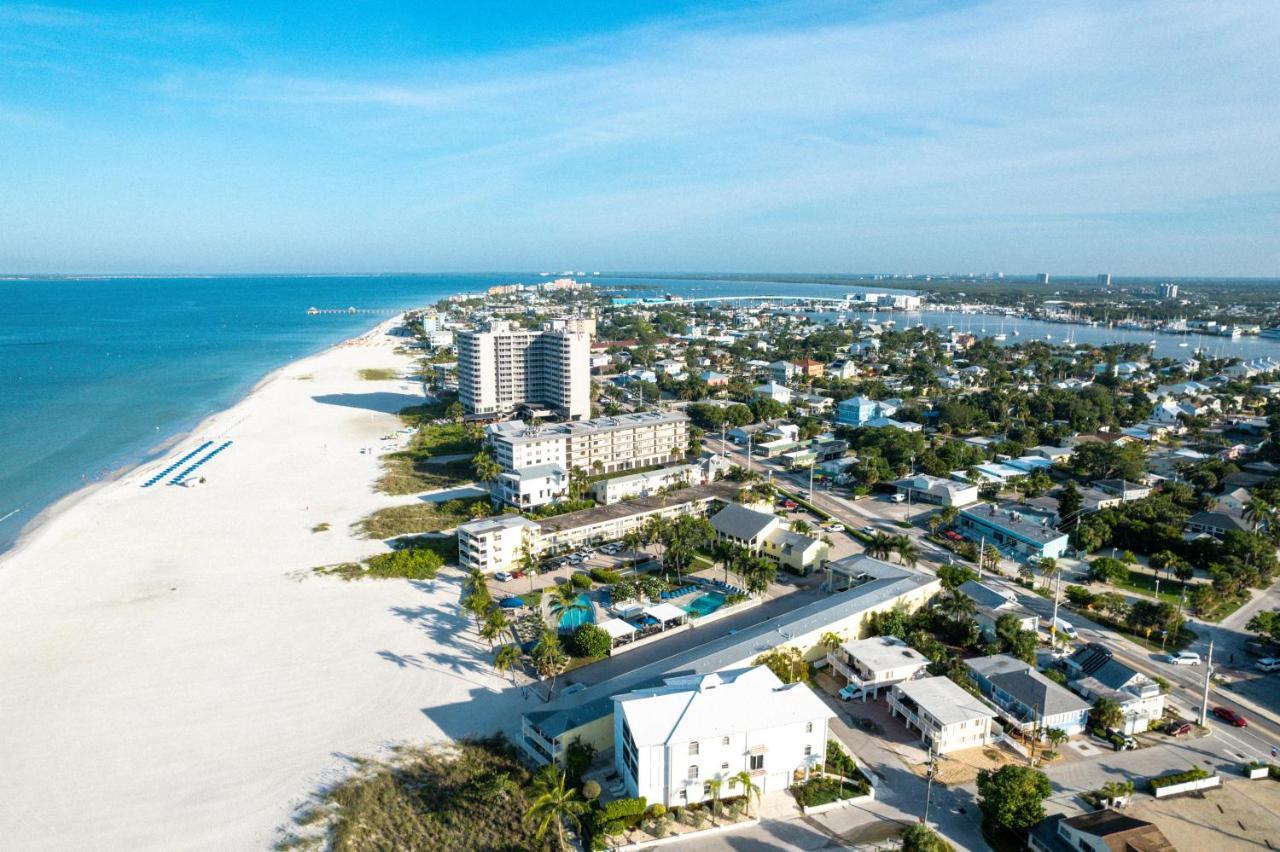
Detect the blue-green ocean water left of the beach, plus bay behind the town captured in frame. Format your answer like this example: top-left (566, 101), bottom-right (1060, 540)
top-left (0, 272), bottom-right (1280, 551)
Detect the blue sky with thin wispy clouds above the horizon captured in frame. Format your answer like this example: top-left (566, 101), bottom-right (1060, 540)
top-left (0, 0), bottom-right (1280, 276)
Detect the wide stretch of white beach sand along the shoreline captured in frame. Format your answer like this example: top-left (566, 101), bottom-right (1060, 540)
top-left (0, 324), bottom-right (521, 849)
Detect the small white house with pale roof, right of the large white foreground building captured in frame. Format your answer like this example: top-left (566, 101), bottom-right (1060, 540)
top-left (888, 677), bottom-right (996, 755)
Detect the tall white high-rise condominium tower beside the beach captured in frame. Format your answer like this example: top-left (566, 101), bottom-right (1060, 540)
top-left (457, 321), bottom-right (591, 420)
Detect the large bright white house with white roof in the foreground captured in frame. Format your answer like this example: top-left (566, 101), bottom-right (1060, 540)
top-left (613, 665), bottom-right (835, 807)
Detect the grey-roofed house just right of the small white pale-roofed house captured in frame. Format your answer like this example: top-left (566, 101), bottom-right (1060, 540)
top-left (964, 654), bottom-right (1091, 737)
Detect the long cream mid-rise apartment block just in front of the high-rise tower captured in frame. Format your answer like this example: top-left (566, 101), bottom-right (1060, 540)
top-left (489, 411), bottom-right (689, 475)
